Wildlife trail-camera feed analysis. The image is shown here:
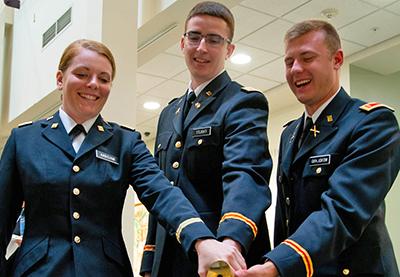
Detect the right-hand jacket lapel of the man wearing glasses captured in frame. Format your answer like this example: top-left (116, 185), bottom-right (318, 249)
top-left (183, 71), bottom-right (231, 130)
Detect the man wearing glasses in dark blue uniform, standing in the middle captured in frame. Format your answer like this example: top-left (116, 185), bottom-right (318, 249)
top-left (141, 1), bottom-right (272, 277)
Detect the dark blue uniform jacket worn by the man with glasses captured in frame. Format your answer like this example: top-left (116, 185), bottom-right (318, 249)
top-left (141, 72), bottom-right (272, 277)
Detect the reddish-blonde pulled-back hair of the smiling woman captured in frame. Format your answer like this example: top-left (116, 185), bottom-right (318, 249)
top-left (58, 39), bottom-right (116, 80)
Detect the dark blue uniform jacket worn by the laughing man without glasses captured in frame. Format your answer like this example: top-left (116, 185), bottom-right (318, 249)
top-left (266, 89), bottom-right (400, 277)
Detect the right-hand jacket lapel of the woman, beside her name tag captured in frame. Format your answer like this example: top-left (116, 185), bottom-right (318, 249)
top-left (76, 115), bottom-right (113, 159)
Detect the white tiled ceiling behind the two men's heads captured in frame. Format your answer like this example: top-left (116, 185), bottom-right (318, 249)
top-left (136, 0), bottom-right (400, 140)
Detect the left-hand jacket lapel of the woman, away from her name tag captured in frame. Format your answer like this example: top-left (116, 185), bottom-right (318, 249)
top-left (41, 112), bottom-right (75, 158)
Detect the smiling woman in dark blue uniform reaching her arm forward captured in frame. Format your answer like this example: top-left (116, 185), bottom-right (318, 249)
top-left (0, 40), bottom-right (244, 276)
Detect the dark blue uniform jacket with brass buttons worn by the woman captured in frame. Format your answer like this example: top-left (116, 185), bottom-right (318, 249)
top-left (0, 112), bottom-right (213, 277)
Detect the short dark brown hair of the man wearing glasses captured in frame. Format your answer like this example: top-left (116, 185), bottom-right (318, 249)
top-left (185, 1), bottom-right (235, 41)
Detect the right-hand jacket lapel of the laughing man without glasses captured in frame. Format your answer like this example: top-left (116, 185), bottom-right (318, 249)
top-left (294, 88), bottom-right (350, 163)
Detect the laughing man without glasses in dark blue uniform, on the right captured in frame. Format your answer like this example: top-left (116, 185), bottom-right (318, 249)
top-left (237, 20), bottom-right (400, 277)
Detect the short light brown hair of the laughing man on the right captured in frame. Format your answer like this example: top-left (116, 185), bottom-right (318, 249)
top-left (284, 19), bottom-right (342, 54)
